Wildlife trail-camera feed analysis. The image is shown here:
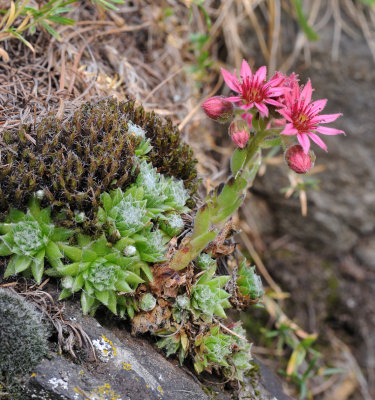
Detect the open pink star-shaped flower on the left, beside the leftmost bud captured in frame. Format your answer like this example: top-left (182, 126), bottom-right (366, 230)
top-left (221, 60), bottom-right (284, 117)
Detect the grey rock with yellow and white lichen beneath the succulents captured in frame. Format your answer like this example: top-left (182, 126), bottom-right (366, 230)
top-left (16, 301), bottom-right (289, 400)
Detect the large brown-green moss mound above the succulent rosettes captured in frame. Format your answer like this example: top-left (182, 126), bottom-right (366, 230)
top-left (0, 99), bottom-right (197, 227)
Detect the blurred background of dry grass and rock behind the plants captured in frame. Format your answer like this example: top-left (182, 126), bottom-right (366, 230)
top-left (0, 0), bottom-right (375, 400)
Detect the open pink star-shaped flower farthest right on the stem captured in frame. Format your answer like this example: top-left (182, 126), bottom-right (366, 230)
top-left (277, 80), bottom-right (345, 154)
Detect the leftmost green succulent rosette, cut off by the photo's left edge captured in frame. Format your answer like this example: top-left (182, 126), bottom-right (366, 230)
top-left (0, 198), bottom-right (73, 283)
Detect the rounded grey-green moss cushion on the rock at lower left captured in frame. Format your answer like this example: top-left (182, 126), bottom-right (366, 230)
top-left (0, 288), bottom-right (48, 385)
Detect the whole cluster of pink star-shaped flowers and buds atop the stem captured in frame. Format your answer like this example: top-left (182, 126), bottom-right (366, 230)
top-left (202, 60), bottom-right (345, 173)
